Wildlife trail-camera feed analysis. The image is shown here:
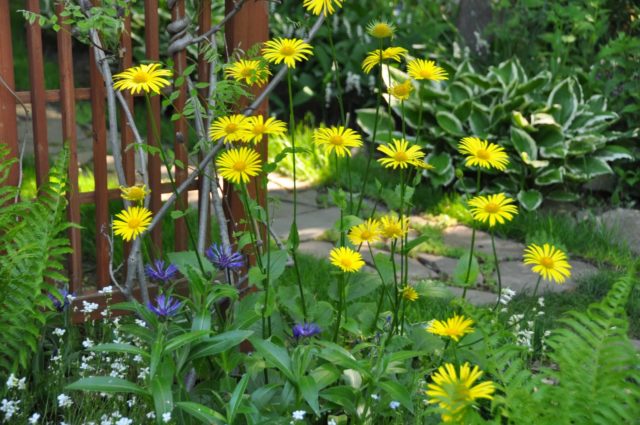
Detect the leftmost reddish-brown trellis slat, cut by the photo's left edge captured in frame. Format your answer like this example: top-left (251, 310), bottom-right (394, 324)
top-left (0, 0), bottom-right (19, 186)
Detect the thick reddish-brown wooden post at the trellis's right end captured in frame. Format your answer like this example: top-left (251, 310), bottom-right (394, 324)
top-left (225, 0), bottom-right (269, 240)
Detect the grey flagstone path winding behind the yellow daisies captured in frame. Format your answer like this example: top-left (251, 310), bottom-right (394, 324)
top-left (269, 181), bottom-right (597, 305)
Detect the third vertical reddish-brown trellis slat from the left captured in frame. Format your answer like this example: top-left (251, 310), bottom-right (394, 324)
top-left (56, 0), bottom-right (82, 293)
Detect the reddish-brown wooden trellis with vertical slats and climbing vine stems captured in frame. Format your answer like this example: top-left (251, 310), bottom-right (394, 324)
top-left (0, 0), bottom-right (269, 306)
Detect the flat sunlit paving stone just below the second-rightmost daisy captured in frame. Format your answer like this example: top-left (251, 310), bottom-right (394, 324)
top-left (443, 225), bottom-right (525, 260)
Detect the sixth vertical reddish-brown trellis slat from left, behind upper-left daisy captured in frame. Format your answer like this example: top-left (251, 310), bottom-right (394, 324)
top-left (144, 0), bottom-right (162, 252)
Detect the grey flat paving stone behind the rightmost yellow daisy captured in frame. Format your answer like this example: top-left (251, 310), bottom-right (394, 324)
top-left (493, 260), bottom-right (598, 294)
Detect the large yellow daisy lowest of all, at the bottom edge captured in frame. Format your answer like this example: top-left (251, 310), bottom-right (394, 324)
top-left (426, 363), bottom-right (496, 423)
